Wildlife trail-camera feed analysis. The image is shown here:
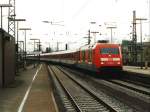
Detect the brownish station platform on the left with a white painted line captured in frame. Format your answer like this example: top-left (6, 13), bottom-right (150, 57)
top-left (0, 64), bottom-right (58, 112)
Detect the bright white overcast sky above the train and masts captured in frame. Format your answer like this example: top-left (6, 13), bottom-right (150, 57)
top-left (0, 0), bottom-right (150, 50)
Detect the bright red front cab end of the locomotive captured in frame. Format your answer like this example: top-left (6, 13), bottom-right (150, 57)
top-left (95, 44), bottom-right (122, 70)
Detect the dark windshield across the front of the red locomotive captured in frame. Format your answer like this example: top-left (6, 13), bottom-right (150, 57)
top-left (100, 48), bottom-right (119, 54)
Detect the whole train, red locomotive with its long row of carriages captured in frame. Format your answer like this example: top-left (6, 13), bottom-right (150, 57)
top-left (41, 43), bottom-right (122, 72)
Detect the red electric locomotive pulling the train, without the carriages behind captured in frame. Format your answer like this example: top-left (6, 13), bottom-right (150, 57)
top-left (77, 43), bottom-right (122, 72)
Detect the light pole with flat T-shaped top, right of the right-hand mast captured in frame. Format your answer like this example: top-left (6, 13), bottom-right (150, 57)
top-left (136, 18), bottom-right (147, 69)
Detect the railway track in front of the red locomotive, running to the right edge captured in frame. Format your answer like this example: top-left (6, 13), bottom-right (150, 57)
top-left (93, 79), bottom-right (150, 112)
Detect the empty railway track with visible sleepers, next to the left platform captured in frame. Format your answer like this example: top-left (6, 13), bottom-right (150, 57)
top-left (48, 67), bottom-right (116, 112)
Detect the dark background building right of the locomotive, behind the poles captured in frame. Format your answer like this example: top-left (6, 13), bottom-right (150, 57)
top-left (122, 40), bottom-right (150, 66)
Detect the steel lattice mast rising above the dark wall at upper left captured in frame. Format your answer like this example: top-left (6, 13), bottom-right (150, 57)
top-left (8, 0), bottom-right (16, 37)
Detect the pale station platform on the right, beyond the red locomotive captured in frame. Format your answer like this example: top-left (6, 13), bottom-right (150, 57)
top-left (123, 66), bottom-right (150, 76)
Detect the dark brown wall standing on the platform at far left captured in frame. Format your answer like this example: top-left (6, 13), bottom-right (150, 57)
top-left (0, 29), bottom-right (16, 87)
